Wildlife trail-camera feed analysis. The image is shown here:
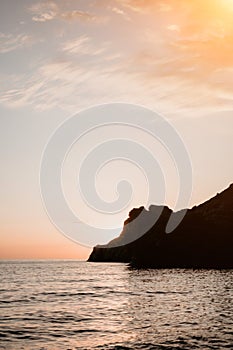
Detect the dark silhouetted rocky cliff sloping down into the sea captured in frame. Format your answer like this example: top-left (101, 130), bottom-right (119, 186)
top-left (88, 185), bottom-right (233, 268)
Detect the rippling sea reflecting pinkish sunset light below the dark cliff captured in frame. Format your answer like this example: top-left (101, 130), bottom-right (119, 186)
top-left (0, 261), bottom-right (233, 350)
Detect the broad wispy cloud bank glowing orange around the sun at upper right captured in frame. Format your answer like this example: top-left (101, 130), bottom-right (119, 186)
top-left (1, 0), bottom-right (233, 115)
